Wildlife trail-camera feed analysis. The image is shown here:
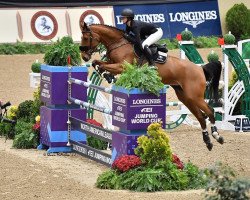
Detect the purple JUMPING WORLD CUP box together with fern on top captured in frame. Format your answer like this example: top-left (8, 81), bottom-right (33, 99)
top-left (112, 62), bottom-right (166, 133)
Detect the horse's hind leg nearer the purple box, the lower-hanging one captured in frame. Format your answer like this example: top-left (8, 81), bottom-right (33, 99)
top-left (173, 86), bottom-right (213, 151)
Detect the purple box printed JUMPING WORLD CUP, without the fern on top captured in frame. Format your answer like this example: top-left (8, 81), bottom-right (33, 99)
top-left (112, 87), bottom-right (166, 132)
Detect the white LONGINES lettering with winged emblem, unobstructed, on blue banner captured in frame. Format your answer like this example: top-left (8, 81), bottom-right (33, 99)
top-left (169, 10), bottom-right (217, 28)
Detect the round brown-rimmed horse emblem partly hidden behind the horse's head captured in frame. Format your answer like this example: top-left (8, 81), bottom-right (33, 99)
top-left (79, 10), bottom-right (104, 26)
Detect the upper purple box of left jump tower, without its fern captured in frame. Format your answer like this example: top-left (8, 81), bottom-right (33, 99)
top-left (41, 65), bottom-right (88, 105)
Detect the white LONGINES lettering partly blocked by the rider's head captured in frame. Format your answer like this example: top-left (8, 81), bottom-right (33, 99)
top-left (116, 13), bottom-right (165, 24)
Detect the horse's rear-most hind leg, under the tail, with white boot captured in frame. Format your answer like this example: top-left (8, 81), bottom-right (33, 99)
top-left (196, 99), bottom-right (224, 144)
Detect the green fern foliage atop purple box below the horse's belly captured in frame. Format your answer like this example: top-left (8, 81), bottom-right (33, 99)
top-left (115, 62), bottom-right (164, 96)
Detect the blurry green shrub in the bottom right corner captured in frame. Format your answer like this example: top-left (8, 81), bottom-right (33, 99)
top-left (206, 163), bottom-right (250, 200)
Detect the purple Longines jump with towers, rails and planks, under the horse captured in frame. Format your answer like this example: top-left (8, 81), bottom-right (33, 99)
top-left (40, 65), bottom-right (166, 166)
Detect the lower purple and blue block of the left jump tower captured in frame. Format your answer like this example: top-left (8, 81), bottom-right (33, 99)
top-left (40, 106), bottom-right (86, 152)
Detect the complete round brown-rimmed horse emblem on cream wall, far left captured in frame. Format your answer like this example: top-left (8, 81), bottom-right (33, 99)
top-left (31, 11), bottom-right (58, 40)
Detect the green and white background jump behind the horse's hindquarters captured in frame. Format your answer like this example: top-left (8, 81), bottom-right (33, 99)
top-left (167, 41), bottom-right (250, 131)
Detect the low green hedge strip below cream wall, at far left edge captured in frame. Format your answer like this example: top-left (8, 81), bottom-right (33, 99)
top-left (0, 41), bottom-right (49, 55)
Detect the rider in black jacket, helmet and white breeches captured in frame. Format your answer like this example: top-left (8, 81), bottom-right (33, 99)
top-left (121, 8), bottom-right (163, 66)
